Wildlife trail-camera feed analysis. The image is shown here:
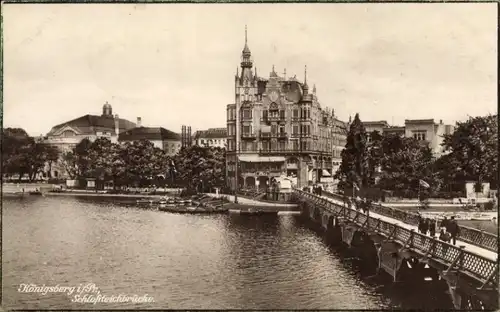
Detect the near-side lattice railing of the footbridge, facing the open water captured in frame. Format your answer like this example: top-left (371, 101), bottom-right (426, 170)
top-left (297, 190), bottom-right (498, 288)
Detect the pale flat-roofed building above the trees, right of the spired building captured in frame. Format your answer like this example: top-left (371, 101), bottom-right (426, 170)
top-left (363, 119), bottom-right (454, 157)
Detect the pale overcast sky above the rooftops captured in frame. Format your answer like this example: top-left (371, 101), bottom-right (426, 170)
top-left (3, 3), bottom-right (498, 135)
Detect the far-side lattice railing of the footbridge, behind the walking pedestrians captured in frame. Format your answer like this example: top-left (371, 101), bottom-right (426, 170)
top-left (322, 191), bottom-right (498, 252)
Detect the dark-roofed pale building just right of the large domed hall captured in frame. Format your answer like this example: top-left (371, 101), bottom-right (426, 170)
top-left (118, 121), bottom-right (181, 156)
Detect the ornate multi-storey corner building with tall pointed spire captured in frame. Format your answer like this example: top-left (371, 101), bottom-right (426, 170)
top-left (226, 27), bottom-right (347, 190)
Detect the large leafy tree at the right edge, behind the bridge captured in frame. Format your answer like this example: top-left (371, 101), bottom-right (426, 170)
top-left (438, 115), bottom-right (498, 188)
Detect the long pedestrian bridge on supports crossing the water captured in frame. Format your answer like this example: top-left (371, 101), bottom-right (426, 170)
top-left (294, 190), bottom-right (499, 310)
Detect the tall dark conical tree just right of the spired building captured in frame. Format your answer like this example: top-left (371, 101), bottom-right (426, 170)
top-left (335, 114), bottom-right (370, 188)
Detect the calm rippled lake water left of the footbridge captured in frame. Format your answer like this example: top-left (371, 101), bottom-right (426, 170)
top-left (2, 197), bottom-right (454, 310)
